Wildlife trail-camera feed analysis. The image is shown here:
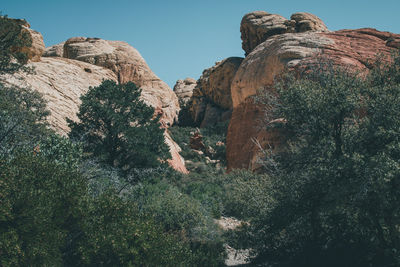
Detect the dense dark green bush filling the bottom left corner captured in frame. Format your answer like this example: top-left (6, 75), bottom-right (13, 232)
top-left (0, 151), bottom-right (86, 266)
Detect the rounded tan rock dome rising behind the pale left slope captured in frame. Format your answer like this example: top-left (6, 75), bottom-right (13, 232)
top-left (63, 37), bottom-right (179, 127)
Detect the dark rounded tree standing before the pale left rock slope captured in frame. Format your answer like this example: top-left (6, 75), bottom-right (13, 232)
top-left (69, 80), bottom-right (170, 178)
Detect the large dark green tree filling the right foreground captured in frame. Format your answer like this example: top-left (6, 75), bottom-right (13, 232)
top-left (241, 55), bottom-right (400, 266)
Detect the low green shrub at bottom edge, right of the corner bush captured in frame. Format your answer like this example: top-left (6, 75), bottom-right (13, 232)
top-left (69, 191), bottom-right (192, 266)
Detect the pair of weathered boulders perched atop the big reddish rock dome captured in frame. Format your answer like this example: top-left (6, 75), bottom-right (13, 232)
top-left (240, 11), bottom-right (328, 55)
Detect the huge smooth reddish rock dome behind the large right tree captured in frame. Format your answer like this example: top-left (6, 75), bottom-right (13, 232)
top-left (227, 13), bottom-right (400, 170)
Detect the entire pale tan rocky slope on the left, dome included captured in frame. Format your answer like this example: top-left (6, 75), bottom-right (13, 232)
top-left (1, 18), bottom-right (187, 172)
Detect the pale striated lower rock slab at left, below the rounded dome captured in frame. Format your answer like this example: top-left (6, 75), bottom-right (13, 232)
top-left (5, 57), bottom-right (117, 135)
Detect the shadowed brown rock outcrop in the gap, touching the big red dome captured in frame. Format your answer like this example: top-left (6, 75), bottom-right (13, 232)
top-left (189, 57), bottom-right (243, 127)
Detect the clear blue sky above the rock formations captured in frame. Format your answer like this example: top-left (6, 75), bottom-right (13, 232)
top-left (0, 0), bottom-right (400, 87)
